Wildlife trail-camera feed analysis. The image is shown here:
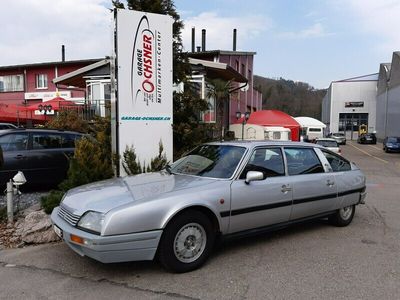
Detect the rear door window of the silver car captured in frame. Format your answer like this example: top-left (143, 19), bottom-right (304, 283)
top-left (285, 148), bottom-right (325, 175)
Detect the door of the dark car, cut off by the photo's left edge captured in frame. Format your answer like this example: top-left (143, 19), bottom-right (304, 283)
top-left (0, 132), bottom-right (30, 185)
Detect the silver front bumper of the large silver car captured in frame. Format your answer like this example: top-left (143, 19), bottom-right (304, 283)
top-left (51, 207), bottom-right (162, 263)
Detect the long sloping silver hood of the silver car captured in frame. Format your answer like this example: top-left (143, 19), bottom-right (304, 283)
top-left (62, 172), bottom-right (215, 215)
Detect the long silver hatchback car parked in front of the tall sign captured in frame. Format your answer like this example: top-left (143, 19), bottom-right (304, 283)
top-left (51, 141), bottom-right (366, 272)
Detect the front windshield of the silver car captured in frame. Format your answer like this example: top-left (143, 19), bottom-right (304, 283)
top-left (171, 145), bottom-right (246, 178)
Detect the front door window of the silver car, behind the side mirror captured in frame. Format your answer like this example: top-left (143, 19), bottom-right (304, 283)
top-left (240, 148), bottom-right (285, 179)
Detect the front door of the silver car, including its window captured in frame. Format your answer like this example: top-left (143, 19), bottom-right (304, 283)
top-left (229, 147), bottom-right (292, 233)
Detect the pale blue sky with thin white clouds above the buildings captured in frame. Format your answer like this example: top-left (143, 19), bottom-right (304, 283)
top-left (0, 0), bottom-right (400, 88)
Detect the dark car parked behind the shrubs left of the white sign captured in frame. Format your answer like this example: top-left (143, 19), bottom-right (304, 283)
top-left (0, 129), bottom-right (83, 186)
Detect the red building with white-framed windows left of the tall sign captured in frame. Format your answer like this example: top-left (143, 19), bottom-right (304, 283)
top-left (0, 59), bottom-right (100, 122)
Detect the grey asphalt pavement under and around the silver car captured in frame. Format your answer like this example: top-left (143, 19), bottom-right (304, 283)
top-left (0, 141), bottom-right (400, 299)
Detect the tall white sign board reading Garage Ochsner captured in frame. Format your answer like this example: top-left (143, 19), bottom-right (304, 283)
top-left (113, 9), bottom-right (173, 175)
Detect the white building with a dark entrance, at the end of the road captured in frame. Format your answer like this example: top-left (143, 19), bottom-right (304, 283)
top-left (322, 73), bottom-right (378, 139)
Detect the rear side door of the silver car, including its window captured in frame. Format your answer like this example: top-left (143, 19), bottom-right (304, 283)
top-left (284, 147), bottom-right (337, 220)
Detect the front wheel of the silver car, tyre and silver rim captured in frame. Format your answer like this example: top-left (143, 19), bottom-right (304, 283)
top-left (158, 210), bottom-right (216, 273)
